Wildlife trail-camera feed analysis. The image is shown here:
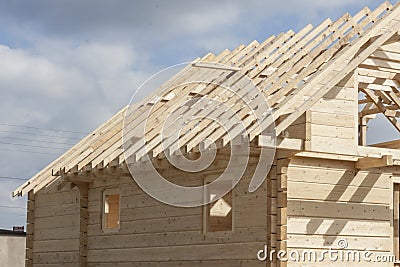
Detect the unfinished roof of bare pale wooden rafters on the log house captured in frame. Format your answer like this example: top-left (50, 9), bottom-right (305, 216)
top-left (13, 2), bottom-right (400, 196)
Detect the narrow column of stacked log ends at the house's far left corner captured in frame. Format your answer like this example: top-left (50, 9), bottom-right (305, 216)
top-left (25, 190), bottom-right (35, 267)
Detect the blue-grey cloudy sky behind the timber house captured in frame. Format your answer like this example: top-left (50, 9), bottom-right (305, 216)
top-left (0, 0), bottom-right (391, 228)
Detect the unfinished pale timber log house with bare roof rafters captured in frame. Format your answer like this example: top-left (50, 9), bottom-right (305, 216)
top-left (13, 2), bottom-right (400, 267)
